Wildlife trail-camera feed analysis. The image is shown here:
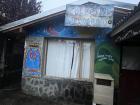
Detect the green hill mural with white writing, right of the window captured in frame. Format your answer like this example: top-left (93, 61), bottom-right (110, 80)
top-left (95, 29), bottom-right (120, 88)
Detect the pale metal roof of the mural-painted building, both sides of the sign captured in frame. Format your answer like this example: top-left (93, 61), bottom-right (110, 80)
top-left (0, 0), bottom-right (135, 31)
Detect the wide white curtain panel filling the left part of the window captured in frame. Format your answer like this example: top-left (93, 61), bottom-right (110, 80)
top-left (46, 40), bottom-right (73, 77)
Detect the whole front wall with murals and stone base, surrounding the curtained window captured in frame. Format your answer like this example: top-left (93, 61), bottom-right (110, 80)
top-left (22, 16), bottom-right (119, 105)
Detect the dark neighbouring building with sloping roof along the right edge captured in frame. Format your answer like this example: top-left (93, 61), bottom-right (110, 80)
top-left (111, 3), bottom-right (140, 105)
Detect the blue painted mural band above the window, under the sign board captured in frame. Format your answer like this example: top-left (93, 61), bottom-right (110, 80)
top-left (27, 16), bottom-right (98, 39)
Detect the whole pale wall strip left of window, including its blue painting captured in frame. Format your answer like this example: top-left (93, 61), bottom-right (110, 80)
top-left (23, 38), bottom-right (41, 77)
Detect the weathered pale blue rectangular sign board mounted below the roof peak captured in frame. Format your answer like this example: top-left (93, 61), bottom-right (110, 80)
top-left (65, 4), bottom-right (114, 28)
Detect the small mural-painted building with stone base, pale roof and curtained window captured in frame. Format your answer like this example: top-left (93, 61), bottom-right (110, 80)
top-left (0, 0), bottom-right (134, 105)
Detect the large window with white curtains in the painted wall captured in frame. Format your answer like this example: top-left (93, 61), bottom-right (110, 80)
top-left (46, 40), bottom-right (94, 79)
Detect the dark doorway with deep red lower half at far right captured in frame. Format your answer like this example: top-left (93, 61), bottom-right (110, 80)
top-left (120, 45), bottom-right (140, 105)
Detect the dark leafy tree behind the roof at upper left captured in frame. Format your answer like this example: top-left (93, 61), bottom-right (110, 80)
top-left (0, 0), bottom-right (41, 24)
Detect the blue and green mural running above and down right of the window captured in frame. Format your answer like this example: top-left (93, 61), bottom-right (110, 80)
top-left (27, 16), bottom-right (120, 87)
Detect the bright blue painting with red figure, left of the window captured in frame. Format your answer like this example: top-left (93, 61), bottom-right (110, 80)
top-left (24, 47), bottom-right (41, 77)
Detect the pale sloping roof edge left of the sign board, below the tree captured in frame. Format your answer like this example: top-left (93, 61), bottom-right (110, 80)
top-left (0, 6), bottom-right (66, 33)
